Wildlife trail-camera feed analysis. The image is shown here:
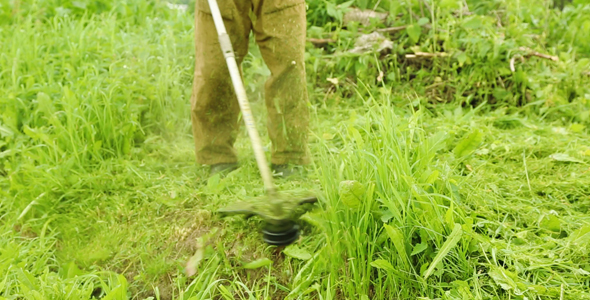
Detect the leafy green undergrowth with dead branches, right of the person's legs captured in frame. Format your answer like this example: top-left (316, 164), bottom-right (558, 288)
top-left (308, 0), bottom-right (590, 122)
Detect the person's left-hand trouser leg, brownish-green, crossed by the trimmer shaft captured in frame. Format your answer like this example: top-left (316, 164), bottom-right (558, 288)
top-left (191, 0), bottom-right (251, 165)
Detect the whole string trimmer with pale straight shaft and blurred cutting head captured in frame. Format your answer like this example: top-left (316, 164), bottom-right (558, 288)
top-left (208, 0), bottom-right (317, 245)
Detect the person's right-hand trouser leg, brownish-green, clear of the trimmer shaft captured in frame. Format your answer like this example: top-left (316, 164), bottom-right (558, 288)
top-left (253, 0), bottom-right (309, 165)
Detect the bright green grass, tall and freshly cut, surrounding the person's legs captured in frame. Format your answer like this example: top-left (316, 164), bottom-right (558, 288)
top-left (0, 2), bottom-right (590, 299)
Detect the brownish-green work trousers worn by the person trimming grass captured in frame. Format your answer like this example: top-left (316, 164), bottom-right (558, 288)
top-left (191, 0), bottom-right (309, 165)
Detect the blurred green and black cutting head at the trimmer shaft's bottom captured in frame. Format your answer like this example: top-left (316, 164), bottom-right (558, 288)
top-left (218, 196), bottom-right (317, 246)
